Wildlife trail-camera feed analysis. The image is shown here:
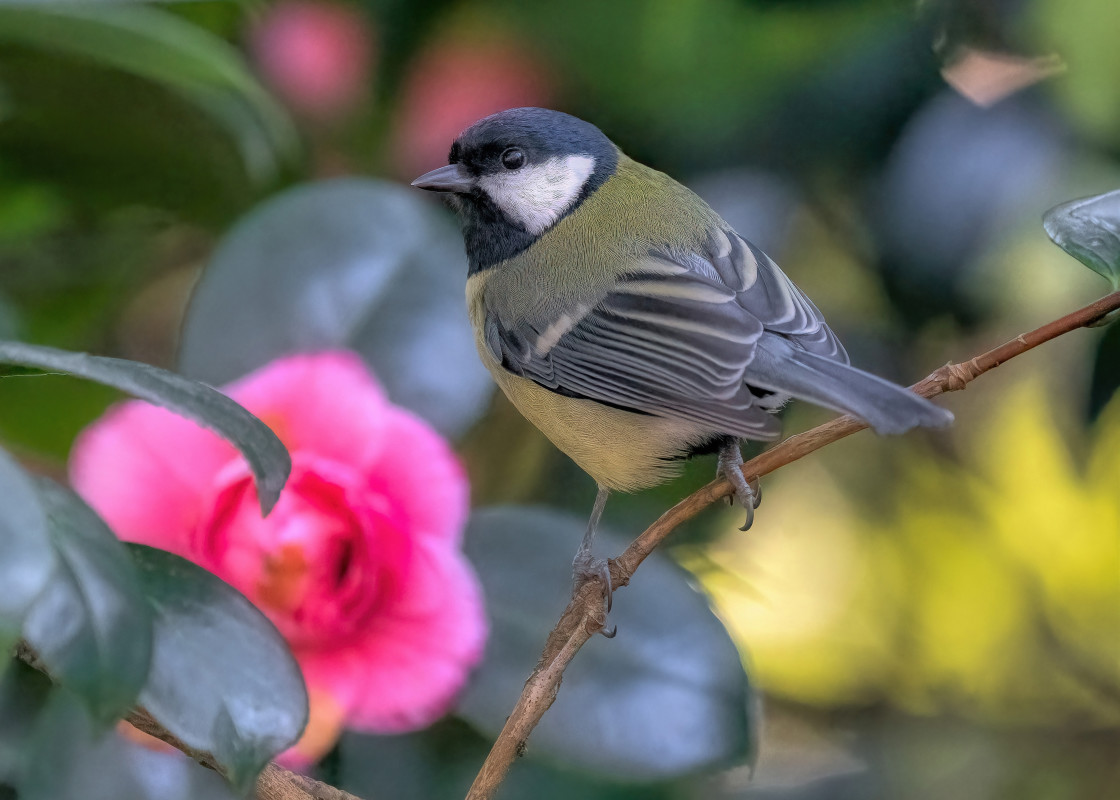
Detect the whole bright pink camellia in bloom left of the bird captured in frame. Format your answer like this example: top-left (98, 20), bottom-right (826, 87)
top-left (71, 352), bottom-right (486, 765)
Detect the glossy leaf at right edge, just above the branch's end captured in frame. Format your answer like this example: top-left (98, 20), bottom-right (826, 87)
top-left (1043, 189), bottom-right (1120, 289)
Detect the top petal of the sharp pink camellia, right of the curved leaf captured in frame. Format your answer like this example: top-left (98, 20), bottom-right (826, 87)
top-left (224, 351), bottom-right (390, 466)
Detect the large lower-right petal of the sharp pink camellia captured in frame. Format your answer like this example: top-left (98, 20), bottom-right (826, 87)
top-left (297, 539), bottom-right (486, 733)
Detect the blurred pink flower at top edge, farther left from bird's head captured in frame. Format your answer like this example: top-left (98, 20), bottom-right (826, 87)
top-left (249, 0), bottom-right (374, 121)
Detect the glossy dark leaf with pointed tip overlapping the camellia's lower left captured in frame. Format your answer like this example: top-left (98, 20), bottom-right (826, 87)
top-left (128, 545), bottom-right (308, 791)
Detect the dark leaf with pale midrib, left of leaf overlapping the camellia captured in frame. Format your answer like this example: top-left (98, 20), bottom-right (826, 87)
top-left (24, 478), bottom-right (151, 722)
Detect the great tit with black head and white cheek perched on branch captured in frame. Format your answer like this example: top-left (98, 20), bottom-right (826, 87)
top-left (412, 108), bottom-right (953, 627)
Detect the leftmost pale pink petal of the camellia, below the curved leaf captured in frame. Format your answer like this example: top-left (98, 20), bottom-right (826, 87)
top-left (69, 400), bottom-right (240, 555)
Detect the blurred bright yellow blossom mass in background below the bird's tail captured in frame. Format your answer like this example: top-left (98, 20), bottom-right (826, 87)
top-left (685, 379), bottom-right (1120, 726)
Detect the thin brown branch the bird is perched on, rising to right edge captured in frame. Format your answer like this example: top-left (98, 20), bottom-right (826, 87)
top-left (467, 291), bottom-right (1120, 800)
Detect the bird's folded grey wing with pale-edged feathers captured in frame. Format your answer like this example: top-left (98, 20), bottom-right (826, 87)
top-left (485, 231), bottom-right (846, 439)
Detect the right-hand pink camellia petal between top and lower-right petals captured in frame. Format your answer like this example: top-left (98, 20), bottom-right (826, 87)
top-left (370, 407), bottom-right (470, 545)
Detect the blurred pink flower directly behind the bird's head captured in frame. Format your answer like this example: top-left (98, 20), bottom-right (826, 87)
top-left (394, 35), bottom-right (553, 179)
